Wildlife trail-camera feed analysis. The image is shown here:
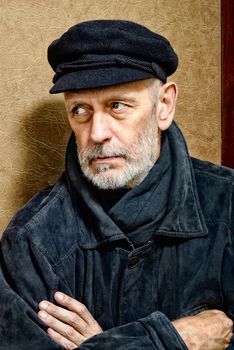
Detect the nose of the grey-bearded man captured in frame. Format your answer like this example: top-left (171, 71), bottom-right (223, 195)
top-left (90, 113), bottom-right (112, 143)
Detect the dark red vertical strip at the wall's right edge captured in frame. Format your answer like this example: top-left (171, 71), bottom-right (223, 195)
top-left (221, 0), bottom-right (234, 168)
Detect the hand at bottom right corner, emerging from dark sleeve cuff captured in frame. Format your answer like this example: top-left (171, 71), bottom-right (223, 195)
top-left (172, 310), bottom-right (233, 350)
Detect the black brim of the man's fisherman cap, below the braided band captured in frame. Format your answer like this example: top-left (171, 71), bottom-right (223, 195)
top-left (50, 67), bottom-right (155, 94)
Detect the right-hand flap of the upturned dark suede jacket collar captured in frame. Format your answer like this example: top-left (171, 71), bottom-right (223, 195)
top-left (155, 122), bottom-right (208, 238)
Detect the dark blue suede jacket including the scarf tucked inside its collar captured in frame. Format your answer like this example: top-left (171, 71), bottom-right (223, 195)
top-left (0, 123), bottom-right (234, 350)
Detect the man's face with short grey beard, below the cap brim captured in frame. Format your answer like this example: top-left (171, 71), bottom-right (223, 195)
top-left (65, 81), bottom-right (160, 189)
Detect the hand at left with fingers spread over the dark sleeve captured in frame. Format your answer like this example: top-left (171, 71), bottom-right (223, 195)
top-left (38, 292), bottom-right (102, 350)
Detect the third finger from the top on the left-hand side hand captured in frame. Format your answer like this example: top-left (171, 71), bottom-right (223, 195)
top-left (38, 311), bottom-right (86, 345)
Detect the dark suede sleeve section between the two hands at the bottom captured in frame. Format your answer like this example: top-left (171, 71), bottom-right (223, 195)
top-left (77, 311), bottom-right (188, 350)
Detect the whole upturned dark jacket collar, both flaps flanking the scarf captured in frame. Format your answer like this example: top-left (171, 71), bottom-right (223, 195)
top-left (66, 123), bottom-right (207, 249)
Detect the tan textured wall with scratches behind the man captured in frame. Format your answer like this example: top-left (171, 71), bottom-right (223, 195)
top-left (0, 0), bottom-right (220, 232)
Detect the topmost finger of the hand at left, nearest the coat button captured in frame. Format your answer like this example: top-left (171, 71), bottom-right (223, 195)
top-left (54, 292), bottom-right (100, 326)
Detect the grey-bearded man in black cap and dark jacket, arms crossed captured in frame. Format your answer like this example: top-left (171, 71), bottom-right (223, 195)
top-left (0, 21), bottom-right (234, 350)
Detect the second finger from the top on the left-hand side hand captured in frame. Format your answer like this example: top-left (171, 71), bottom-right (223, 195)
top-left (39, 301), bottom-right (89, 336)
